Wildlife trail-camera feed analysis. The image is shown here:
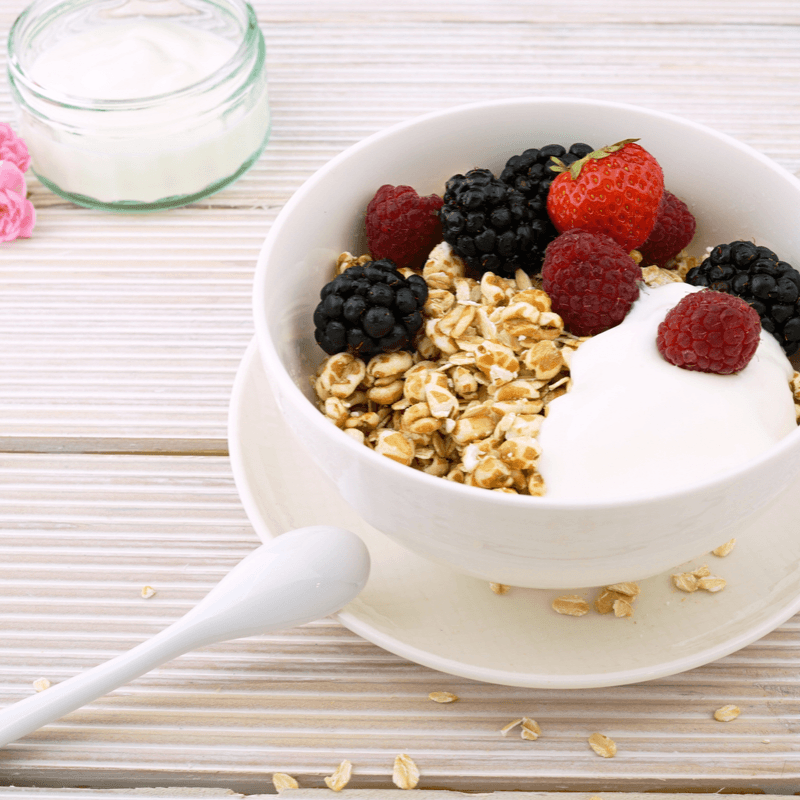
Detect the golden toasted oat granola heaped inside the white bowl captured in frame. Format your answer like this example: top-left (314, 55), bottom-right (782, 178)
top-left (313, 244), bottom-right (584, 496)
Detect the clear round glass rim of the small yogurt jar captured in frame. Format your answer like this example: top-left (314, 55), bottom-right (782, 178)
top-left (7, 0), bottom-right (261, 111)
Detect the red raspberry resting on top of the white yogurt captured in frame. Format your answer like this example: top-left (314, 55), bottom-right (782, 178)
top-left (656, 289), bottom-right (761, 375)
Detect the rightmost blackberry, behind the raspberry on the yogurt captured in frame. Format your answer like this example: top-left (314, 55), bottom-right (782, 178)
top-left (686, 241), bottom-right (800, 356)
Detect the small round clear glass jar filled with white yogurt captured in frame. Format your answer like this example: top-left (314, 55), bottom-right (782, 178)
top-left (8, 0), bottom-right (270, 211)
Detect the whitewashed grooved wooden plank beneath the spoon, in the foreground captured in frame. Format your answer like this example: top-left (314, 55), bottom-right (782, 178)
top-left (0, 454), bottom-right (800, 800)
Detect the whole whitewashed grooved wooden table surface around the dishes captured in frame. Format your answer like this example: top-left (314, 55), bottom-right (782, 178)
top-left (0, 0), bottom-right (800, 798)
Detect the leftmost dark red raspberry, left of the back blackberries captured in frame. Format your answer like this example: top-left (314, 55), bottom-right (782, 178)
top-left (366, 183), bottom-right (442, 267)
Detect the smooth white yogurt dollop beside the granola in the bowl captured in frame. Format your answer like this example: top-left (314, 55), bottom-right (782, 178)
top-left (539, 283), bottom-right (797, 500)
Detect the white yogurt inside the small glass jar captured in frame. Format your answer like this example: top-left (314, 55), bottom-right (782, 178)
top-left (13, 17), bottom-right (269, 205)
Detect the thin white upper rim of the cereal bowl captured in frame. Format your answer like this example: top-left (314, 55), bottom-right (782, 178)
top-left (252, 96), bottom-right (800, 512)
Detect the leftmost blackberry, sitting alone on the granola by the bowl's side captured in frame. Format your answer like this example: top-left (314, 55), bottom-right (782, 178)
top-left (314, 259), bottom-right (428, 361)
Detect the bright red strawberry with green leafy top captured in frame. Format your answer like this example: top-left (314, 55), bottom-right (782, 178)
top-left (547, 139), bottom-right (664, 251)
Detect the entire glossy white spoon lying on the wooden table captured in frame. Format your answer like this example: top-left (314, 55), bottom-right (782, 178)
top-left (0, 525), bottom-right (369, 747)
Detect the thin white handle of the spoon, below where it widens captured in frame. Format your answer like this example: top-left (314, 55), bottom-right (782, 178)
top-left (0, 620), bottom-right (195, 747)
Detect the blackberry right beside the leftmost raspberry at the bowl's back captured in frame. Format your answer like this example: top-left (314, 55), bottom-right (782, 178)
top-left (439, 169), bottom-right (544, 276)
